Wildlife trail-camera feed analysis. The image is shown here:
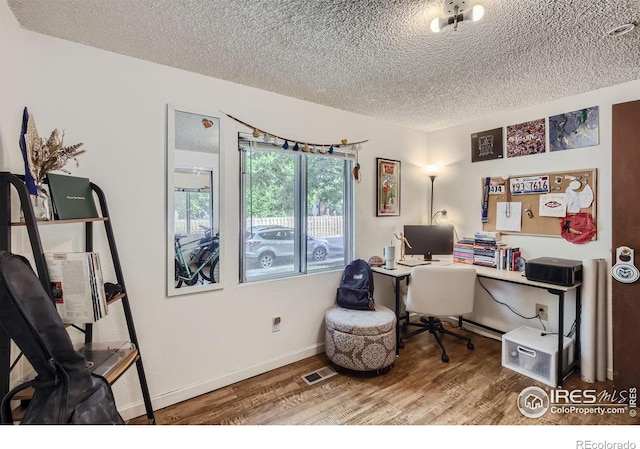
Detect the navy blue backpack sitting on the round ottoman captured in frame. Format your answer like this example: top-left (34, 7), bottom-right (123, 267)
top-left (336, 259), bottom-right (376, 310)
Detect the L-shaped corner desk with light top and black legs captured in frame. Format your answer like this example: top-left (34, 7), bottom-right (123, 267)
top-left (371, 261), bottom-right (582, 387)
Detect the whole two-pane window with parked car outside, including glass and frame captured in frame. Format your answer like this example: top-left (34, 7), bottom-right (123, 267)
top-left (238, 134), bottom-right (353, 282)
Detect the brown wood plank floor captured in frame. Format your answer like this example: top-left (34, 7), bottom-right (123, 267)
top-left (129, 324), bottom-right (639, 425)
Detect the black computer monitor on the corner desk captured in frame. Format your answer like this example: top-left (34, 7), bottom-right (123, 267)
top-left (404, 225), bottom-right (454, 262)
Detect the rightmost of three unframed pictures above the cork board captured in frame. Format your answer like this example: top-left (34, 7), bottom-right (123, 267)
top-left (549, 106), bottom-right (600, 151)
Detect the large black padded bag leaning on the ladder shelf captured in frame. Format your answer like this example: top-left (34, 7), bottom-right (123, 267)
top-left (0, 251), bottom-right (125, 425)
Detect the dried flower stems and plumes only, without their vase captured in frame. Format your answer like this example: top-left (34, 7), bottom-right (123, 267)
top-left (25, 114), bottom-right (86, 184)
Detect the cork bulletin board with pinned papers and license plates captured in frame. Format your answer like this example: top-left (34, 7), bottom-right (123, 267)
top-left (481, 168), bottom-right (598, 240)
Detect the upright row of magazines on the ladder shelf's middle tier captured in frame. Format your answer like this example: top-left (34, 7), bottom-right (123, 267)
top-left (44, 252), bottom-right (108, 323)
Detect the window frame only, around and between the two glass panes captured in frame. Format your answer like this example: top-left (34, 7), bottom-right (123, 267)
top-left (238, 133), bottom-right (355, 284)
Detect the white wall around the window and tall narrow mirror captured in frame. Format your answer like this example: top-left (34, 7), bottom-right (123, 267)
top-left (0, 16), bottom-right (426, 418)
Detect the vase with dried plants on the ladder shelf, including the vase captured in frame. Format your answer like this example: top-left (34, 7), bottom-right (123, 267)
top-left (23, 108), bottom-right (85, 220)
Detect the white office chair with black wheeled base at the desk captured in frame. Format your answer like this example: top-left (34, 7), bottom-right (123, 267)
top-left (404, 265), bottom-right (476, 362)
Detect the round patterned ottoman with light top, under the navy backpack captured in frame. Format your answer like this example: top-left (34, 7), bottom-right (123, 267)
top-left (324, 304), bottom-right (396, 371)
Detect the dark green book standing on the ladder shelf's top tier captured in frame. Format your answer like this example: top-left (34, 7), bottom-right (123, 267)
top-left (47, 173), bottom-right (98, 220)
